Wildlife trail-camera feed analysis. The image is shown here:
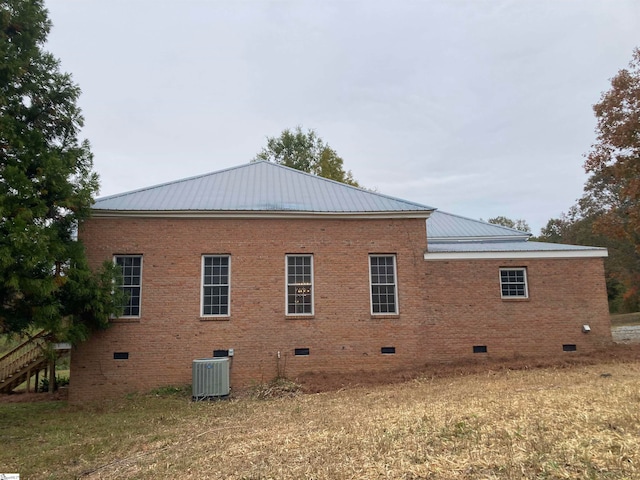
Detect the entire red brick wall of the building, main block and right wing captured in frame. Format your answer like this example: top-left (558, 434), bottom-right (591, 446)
top-left (70, 218), bottom-right (610, 402)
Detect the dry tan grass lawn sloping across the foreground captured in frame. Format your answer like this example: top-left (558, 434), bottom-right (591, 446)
top-left (0, 362), bottom-right (640, 479)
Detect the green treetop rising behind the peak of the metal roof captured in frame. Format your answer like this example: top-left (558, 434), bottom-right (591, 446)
top-left (253, 127), bottom-right (359, 187)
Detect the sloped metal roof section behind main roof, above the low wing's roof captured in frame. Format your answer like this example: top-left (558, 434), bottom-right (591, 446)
top-left (427, 210), bottom-right (531, 243)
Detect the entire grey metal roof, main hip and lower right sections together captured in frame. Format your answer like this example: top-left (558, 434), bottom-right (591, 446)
top-left (93, 161), bottom-right (606, 259)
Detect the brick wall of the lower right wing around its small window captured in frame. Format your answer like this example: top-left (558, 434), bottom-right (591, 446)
top-left (424, 258), bottom-right (611, 361)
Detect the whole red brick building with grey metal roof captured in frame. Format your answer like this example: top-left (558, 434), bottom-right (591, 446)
top-left (70, 162), bottom-right (611, 402)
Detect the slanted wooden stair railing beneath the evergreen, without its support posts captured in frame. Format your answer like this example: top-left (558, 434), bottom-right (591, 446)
top-left (0, 330), bottom-right (58, 393)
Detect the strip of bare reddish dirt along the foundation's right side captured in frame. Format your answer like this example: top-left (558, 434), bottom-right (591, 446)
top-left (294, 343), bottom-right (640, 393)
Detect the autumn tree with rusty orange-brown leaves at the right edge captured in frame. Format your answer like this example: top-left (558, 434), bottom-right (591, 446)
top-left (580, 48), bottom-right (640, 252)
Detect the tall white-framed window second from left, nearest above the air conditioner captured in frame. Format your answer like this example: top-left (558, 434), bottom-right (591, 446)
top-left (202, 255), bottom-right (229, 317)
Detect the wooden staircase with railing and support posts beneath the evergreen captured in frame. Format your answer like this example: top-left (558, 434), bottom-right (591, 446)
top-left (0, 331), bottom-right (70, 393)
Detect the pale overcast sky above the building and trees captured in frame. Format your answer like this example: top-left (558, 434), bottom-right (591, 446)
top-left (45, 0), bottom-right (640, 234)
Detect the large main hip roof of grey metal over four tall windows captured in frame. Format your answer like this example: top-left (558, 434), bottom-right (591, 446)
top-left (93, 161), bottom-right (433, 218)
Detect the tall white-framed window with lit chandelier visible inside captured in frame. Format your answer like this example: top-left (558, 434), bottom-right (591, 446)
top-left (287, 255), bottom-right (313, 315)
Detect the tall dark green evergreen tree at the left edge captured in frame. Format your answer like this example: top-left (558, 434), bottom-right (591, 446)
top-left (0, 0), bottom-right (122, 342)
